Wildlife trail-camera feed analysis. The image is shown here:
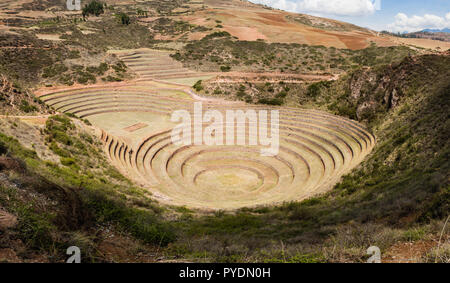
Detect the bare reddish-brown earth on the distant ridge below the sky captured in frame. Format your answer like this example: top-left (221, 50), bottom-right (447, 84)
top-left (178, 0), bottom-right (450, 50)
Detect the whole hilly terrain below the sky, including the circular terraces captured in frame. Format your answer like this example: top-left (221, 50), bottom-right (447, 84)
top-left (0, 0), bottom-right (450, 263)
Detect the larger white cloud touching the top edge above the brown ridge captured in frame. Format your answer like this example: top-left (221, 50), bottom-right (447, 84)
top-left (250, 0), bottom-right (379, 16)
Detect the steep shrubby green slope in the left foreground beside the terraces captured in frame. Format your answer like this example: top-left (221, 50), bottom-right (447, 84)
top-left (0, 115), bottom-right (175, 262)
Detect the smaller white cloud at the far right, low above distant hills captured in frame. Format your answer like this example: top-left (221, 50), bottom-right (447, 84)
top-left (388, 13), bottom-right (450, 32)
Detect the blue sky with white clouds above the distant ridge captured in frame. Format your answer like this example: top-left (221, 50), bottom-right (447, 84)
top-left (249, 0), bottom-right (450, 33)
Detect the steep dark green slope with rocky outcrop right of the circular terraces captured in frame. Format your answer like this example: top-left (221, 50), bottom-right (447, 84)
top-left (318, 54), bottom-right (450, 222)
